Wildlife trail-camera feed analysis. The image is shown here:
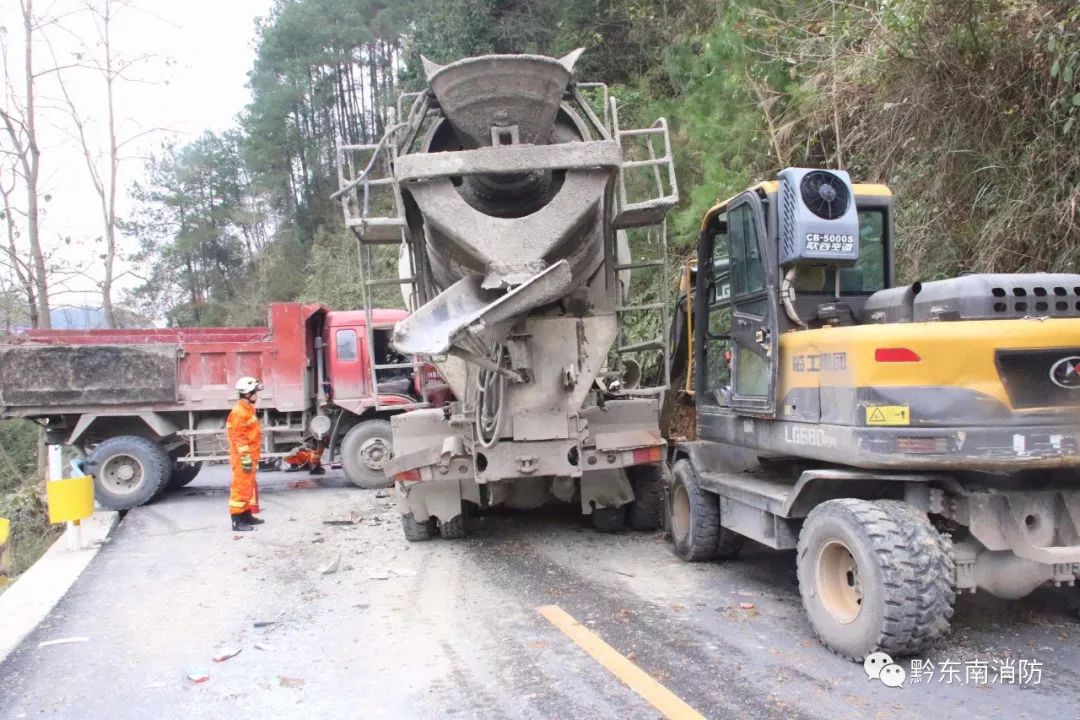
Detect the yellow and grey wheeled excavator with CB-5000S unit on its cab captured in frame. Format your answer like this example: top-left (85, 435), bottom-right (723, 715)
top-left (663, 168), bottom-right (1080, 660)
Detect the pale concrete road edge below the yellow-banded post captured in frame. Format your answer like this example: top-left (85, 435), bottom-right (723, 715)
top-left (0, 511), bottom-right (120, 663)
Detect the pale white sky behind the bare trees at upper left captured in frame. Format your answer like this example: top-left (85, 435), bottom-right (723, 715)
top-left (0, 0), bottom-right (273, 307)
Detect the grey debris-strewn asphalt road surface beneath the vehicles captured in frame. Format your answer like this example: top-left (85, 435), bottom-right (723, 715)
top-left (0, 468), bottom-right (1080, 720)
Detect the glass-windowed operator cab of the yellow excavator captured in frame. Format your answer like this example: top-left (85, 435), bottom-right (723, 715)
top-left (671, 171), bottom-right (895, 423)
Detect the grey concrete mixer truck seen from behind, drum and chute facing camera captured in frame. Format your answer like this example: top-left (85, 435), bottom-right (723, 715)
top-left (335, 51), bottom-right (678, 541)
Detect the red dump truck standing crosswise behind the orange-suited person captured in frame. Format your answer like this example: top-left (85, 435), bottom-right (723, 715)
top-left (0, 302), bottom-right (450, 510)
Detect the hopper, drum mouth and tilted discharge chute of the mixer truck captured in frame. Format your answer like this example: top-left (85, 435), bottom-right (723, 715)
top-left (394, 47), bottom-right (615, 355)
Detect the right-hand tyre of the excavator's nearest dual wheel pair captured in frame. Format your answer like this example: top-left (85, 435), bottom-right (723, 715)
top-left (877, 500), bottom-right (956, 653)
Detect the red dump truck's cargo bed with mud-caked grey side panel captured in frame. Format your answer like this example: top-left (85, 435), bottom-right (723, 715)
top-left (0, 303), bottom-right (324, 417)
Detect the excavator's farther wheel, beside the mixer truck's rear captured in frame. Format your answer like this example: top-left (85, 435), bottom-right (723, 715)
top-left (667, 460), bottom-right (744, 562)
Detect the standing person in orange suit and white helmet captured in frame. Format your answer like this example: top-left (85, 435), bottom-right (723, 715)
top-left (225, 377), bottom-right (264, 532)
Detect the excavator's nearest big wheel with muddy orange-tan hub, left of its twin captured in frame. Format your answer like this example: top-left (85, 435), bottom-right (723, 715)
top-left (797, 498), bottom-right (937, 661)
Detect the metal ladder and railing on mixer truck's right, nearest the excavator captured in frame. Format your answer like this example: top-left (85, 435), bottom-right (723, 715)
top-left (608, 98), bottom-right (678, 396)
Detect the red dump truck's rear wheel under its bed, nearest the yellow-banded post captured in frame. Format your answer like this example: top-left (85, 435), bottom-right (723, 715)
top-left (90, 435), bottom-right (173, 510)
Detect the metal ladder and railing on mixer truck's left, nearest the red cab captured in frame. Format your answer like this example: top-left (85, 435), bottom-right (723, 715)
top-left (332, 93), bottom-right (445, 410)
